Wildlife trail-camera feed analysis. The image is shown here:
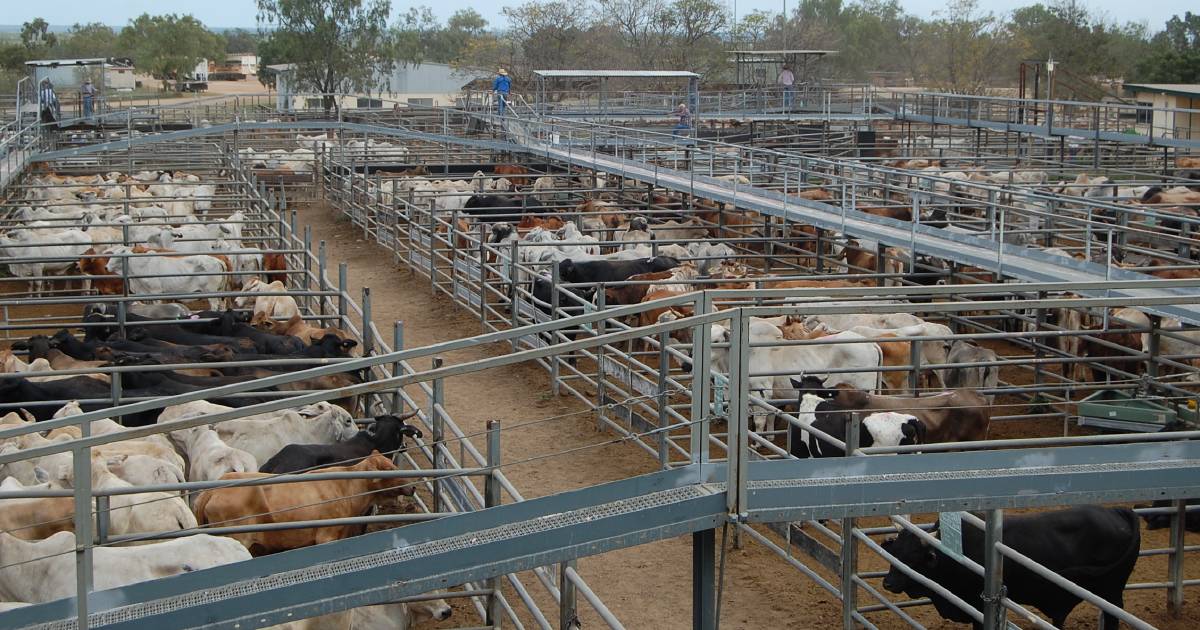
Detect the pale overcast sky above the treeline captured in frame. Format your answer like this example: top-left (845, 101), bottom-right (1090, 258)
top-left (0, 0), bottom-right (1180, 30)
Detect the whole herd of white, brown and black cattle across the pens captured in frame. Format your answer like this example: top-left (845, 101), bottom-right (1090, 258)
top-left (0, 142), bottom-right (1200, 628)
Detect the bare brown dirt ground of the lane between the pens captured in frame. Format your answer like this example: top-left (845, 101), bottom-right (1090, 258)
top-left (299, 206), bottom-right (1200, 630)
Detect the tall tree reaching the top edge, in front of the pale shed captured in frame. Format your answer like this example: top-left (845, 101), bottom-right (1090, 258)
top-left (257, 0), bottom-right (397, 115)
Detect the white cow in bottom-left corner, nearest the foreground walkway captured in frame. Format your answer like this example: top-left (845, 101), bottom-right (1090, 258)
top-left (0, 532), bottom-right (251, 602)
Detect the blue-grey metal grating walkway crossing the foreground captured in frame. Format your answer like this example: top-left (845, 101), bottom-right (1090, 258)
top-left (9, 442), bottom-right (1200, 630)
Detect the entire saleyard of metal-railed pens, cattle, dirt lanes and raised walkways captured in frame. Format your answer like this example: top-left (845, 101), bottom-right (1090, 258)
top-left (0, 65), bottom-right (1200, 630)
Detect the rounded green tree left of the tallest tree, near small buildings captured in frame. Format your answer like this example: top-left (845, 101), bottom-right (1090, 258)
top-left (118, 13), bottom-right (224, 89)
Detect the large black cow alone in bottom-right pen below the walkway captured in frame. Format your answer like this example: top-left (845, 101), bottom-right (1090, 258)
top-left (883, 505), bottom-right (1141, 630)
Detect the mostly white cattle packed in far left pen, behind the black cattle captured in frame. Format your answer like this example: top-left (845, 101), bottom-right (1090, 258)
top-left (0, 170), bottom-right (287, 301)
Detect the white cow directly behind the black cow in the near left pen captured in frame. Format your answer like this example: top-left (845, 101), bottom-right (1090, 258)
top-left (158, 401), bottom-right (358, 462)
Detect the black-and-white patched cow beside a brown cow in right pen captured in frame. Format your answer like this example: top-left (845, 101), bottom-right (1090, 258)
top-left (788, 393), bottom-right (925, 460)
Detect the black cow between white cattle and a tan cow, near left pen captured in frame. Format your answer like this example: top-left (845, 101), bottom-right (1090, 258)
top-left (258, 412), bottom-right (422, 474)
